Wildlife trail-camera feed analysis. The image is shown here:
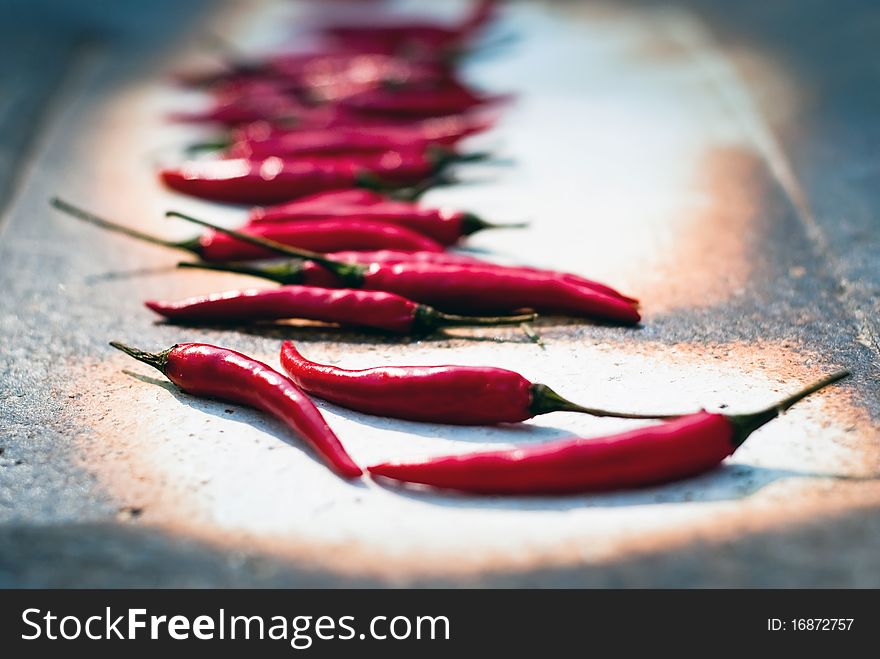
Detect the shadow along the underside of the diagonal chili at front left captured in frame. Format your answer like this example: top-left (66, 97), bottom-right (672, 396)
top-left (116, 369), bottom-right (367, 489)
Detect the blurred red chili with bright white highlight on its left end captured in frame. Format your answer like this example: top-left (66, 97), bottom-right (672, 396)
top-left (161, 152), bottom-right (438, 204)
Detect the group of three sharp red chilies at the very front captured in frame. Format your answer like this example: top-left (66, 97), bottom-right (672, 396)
top-left (111, 342), bottom-right (849, 494)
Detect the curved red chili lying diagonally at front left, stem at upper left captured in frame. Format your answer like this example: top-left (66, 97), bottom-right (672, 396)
top-left (110, 341), bottom-right (363, 478)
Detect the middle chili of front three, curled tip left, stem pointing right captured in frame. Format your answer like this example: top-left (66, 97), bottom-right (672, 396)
top-left (281, 341), bottom-right (668, 426)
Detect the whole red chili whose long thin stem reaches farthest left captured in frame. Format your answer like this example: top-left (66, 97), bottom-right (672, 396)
top-left (52, 198), bottom-right (443, 261)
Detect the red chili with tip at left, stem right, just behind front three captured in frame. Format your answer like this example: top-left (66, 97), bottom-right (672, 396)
top-left (145, 285), bottom-right (535, 334)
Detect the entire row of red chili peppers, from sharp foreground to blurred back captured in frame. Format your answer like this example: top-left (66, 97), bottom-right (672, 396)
top-left (65, 0), bottom-right (847, 494)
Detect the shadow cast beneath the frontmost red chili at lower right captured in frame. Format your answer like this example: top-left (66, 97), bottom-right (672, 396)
top-left (372, 464), bottom-right (868, 512)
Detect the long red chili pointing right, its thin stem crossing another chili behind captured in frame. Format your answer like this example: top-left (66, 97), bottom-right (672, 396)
top-left (163, 212), bottom-right (641, 324)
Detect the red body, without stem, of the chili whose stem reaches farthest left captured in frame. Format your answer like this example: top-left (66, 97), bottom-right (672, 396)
top-left (197, 219), bottom-right (443, 261)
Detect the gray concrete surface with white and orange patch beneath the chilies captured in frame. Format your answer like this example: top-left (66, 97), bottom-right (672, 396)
top-left (0, 1), bottom-right (880, 587)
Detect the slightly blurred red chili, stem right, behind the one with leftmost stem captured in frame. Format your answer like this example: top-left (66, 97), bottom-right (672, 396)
top-left (249, 200), bottom-right (526, 245)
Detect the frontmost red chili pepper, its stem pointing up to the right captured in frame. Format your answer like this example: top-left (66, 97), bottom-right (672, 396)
top-left (367, 371), bottom-right (849, 494)
